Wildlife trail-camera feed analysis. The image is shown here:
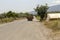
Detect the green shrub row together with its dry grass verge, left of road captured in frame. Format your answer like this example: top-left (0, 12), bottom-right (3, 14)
top-left (0, 11), bottom-right (32, 23)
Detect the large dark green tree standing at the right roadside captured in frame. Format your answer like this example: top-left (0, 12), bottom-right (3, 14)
top-left (35, 4), bottom-right (48, 21)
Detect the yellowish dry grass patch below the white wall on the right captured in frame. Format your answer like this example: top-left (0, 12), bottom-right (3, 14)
top-left (44, 20), bottom-right (60, 31)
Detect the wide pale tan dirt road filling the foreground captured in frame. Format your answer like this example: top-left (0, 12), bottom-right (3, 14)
top-left (0, 19), bottom-right (52, 40)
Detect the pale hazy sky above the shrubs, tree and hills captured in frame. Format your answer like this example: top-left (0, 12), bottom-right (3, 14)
top-left (0, 0), bottom-right (60, 13)
